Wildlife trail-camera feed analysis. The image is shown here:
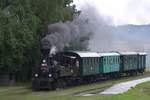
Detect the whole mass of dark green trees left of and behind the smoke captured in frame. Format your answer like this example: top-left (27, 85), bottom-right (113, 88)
top-left (0, 0), bottom-right (79, 81)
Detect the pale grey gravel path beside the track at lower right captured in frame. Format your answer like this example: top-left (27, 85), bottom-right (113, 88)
top-left (100, 77), bottom-right (150, 94)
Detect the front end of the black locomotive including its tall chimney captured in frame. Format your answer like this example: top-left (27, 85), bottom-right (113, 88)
top-left (32, 39), bottom-right (55, 90)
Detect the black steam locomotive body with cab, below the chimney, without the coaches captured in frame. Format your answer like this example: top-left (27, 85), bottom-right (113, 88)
top-left (32, 48), bottom-right (79, 90)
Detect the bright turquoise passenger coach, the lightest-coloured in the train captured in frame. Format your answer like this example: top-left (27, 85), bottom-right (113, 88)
top-left (99, 52), bottom-right (120, 74)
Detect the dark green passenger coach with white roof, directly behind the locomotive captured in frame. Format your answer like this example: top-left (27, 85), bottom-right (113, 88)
top-left (72, 51), bottom-right (100, 76)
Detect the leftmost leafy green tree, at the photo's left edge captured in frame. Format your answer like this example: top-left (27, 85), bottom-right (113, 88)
top-left (0, 0), bottom-right (39, 80)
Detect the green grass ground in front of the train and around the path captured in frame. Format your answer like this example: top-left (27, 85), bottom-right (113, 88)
top-left (0, 73), bottom-right (150, 100)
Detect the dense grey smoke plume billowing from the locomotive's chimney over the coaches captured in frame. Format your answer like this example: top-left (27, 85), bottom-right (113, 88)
top-left (42, 6), bottom-right (97, 52)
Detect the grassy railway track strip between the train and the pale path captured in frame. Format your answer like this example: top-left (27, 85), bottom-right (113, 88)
top-left (58, 73), bottom-right (150, 96)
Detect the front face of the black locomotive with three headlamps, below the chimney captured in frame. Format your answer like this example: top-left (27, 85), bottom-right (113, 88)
top-left (32, 59), bottom-right (54, 90)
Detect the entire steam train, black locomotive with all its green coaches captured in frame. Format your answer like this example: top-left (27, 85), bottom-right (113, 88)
top-left (32, 47), bottom-right (146, 90)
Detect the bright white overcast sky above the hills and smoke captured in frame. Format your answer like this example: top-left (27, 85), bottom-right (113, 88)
top-left (74, 0), bottom-right (150, 25)
